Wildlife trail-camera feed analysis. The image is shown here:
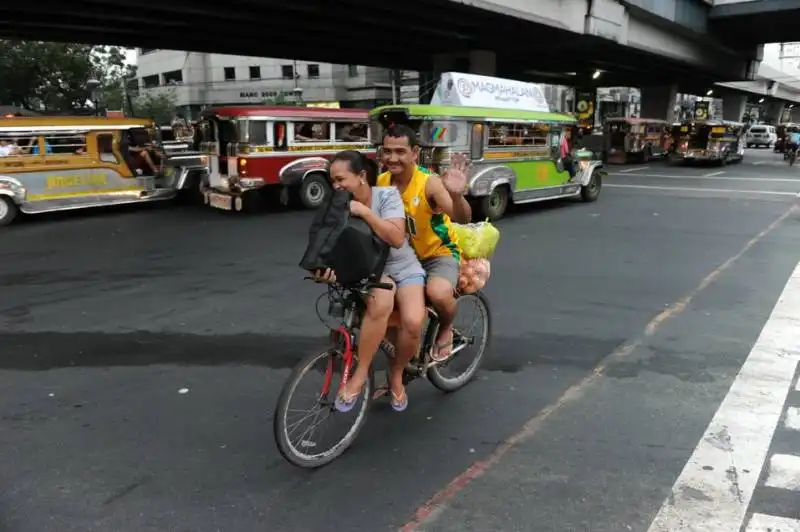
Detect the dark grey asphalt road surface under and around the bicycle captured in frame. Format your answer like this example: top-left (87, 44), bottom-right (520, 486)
top-left (0, 150), bottom-right (800, 532)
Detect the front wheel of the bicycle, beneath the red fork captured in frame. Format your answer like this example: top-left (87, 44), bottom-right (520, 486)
top-left (272, 348), bottom-right (375, 468)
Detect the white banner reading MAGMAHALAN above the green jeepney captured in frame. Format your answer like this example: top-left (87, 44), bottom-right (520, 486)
top-left (431, 72), bottom-right (550, 113)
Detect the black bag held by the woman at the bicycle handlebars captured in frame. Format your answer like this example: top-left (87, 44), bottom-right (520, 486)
top-left (300, 190), bottom-right (389, 286)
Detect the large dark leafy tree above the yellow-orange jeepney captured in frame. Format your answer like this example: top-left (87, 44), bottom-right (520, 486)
top-left (0, 40), bottom-right (125, 111)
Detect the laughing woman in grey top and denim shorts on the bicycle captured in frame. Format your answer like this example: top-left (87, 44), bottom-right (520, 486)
top-left (315, 150), bottom-right (425, 412)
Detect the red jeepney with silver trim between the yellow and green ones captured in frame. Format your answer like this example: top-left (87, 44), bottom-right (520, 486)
top-left (198, 106), bottom-right (375, 211)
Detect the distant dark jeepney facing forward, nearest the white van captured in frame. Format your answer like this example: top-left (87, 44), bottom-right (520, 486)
top-left (668, 120), bottom-right (745, 166)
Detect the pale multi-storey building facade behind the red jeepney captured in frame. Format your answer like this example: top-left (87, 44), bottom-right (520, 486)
top-left (136, 48), bottom-right (392, 118)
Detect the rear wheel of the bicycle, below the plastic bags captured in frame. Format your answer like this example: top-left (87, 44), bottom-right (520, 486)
top-left (427, 291), bottom-right (492, 392)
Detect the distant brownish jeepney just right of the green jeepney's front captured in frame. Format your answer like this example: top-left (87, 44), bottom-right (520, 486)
top-left (603, 118), bottom-right (669, 164)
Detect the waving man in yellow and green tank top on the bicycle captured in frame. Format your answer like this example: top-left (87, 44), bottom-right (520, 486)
top-left (377, 125), bottom-right (472, 374)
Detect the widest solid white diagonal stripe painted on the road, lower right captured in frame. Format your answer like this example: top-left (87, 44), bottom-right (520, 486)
top-left (648, 264), bottom-right (800, 532)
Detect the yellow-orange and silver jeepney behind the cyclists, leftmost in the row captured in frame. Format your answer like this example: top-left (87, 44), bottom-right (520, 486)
top-left (0, 116), bottom-right (207, 226)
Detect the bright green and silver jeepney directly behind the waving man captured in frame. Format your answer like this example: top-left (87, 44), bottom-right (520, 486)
top-left (370, 105), bottom-right (605, 220)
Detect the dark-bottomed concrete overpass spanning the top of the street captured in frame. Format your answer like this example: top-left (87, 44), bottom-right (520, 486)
top-left (0, 0), bottom-right (756, 93)
